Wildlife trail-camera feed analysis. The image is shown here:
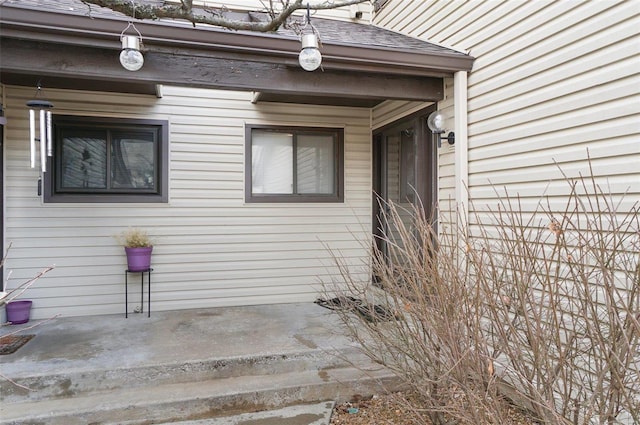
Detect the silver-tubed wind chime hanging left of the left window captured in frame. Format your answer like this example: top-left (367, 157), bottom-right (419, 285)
top-left (27, 83), bottom-right (53, 173)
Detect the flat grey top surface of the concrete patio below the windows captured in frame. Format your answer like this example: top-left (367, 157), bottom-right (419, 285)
top-left (2, 303), bottom-right (354, 376)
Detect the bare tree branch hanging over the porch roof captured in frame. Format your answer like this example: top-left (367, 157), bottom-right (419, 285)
top-left (82, 0), bottom-right (370, 32)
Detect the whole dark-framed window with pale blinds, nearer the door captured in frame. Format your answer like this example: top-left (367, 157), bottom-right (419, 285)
top-left (245, 125), bottom-right (344, 202)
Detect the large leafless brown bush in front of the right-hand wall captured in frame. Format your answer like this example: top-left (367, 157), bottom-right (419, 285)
top-left (328, 167), bottom-right (640, 425)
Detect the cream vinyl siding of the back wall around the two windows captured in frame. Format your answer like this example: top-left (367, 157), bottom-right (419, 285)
top-left (5, 86), bottom-right (371, 318)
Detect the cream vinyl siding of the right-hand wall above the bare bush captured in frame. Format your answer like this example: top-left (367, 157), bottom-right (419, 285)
top-left (375, 0), bottom-right (640, 219)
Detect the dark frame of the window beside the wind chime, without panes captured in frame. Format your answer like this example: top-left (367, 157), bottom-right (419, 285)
top-left (43, 114), bottom-right (169, 203)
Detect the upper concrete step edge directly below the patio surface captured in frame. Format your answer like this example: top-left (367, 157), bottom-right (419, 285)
top-left (0, 347), bottom-right (369, 403)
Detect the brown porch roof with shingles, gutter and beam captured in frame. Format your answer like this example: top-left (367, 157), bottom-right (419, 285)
top-left (0, 0), bottom-right (473, 107)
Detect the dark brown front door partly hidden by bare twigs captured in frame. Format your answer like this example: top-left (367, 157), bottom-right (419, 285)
top-left (373, 108), bottom-right (437, 266)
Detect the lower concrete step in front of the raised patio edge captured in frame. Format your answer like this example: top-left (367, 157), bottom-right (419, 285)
top-left (0, 364), bottom-right (399, 425)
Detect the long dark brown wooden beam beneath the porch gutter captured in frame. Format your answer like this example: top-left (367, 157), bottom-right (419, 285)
top-left (0, 38), bottom-right (443, 102)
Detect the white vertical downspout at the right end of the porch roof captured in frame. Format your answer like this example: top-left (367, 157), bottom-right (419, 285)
top-left (453, 71), bottom-right (469, 229)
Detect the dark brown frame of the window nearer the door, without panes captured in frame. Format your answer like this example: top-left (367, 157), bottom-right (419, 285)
top-left (244, 124), bottom-right (344, 203)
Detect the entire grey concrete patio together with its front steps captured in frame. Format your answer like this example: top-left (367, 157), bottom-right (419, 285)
top-left (0, 303), bottom-right (397, 425)
